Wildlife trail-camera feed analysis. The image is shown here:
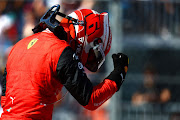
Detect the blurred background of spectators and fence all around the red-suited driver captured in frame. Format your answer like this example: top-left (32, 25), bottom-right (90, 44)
top-left (0, 0), bottom-right (180, 120)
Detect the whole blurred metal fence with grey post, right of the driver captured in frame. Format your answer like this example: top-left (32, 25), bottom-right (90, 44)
top-left (107, 0), bottom-right (180, 120)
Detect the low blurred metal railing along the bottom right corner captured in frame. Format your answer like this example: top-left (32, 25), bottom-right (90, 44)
top-left (121, 103), bottom-right (180, 120)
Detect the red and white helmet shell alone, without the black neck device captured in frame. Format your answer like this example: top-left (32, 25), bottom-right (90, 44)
top-left (68, 9), bottom-right (112, 72)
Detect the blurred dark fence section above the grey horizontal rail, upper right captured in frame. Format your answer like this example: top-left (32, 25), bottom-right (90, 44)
top-left (121, 0), bottom-right (180, 35)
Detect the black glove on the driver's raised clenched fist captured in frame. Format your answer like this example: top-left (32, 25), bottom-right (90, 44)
top-left (107, 53), bottom-right (129, 91)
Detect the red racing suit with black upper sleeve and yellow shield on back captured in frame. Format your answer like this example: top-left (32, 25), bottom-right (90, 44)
top-left (1, 30), bottom-right (118, 120)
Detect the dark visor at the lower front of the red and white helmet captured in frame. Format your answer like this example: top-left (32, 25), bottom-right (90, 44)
top-left (85, 45), bottom-right (105, 72)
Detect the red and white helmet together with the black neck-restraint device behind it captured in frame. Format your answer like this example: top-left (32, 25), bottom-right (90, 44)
top-left (33, 5), bottom-right (112, 72)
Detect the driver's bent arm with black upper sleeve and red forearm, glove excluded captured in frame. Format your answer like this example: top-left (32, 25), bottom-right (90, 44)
top-left (56, 47), bottom-right (118, 110)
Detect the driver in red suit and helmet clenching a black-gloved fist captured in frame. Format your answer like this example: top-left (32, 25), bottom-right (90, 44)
top-left (1, 5), bottom-right (128, 120)
